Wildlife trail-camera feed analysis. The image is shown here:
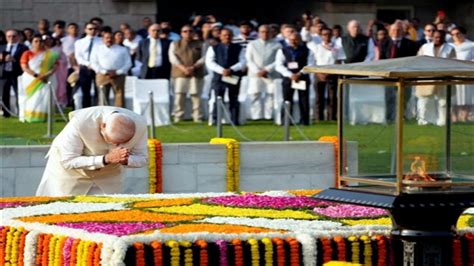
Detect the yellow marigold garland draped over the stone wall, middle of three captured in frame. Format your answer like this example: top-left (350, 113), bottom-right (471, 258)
top-left (210, 138), bottom-right (240, 191)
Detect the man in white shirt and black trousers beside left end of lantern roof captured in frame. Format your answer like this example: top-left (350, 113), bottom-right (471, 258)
top-left (308, 28), bottom-right (344, 121)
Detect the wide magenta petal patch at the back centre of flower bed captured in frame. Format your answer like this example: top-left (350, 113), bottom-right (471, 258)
top-left (203, 194), bottom-right (330, 209)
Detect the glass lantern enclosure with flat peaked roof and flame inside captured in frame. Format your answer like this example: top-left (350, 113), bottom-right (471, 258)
top-left (305, 56), bottom-right (474, 195)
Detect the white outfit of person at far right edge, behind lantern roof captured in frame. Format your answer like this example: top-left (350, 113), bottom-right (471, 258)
top-left (452, 40), bottom-right (474, 106)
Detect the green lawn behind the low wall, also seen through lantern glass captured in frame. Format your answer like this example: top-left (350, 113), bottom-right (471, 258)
top-left (0, 117), bottom-right (474, 175)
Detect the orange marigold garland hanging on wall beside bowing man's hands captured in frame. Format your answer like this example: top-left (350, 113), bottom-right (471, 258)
top-left (148, 139), bottom-right (163, 193)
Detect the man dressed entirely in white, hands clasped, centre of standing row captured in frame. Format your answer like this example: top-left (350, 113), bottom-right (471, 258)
top-left (245, 25), bottom-right (281, 120)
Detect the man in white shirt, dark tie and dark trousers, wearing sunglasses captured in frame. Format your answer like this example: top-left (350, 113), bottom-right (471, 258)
top-left (74, 22), bottom-right (102, 108)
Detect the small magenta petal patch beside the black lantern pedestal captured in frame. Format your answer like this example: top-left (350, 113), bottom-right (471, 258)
top-left (314, 204), bottom-right (388, 218)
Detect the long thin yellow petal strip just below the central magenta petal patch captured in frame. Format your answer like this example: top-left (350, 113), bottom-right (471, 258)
top-left (147, 203), bottom-right (318, 220)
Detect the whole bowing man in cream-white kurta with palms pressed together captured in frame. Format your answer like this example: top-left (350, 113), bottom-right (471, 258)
top-left (36, 106), bottom-right (148, 196)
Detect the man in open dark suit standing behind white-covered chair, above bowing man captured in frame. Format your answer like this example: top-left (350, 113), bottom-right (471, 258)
top-left (138, 24), bottom-right (171, 79)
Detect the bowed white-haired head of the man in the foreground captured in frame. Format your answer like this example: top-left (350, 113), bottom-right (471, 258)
top-left (104, 113), bottom-right (136, 144)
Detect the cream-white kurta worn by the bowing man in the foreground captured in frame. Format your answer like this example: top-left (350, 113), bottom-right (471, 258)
top-left (36, 106), bottom-right (148, 196)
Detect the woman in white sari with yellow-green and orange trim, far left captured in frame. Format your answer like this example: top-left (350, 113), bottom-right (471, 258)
top-left (20, 35), bottom-right (59, 122)
